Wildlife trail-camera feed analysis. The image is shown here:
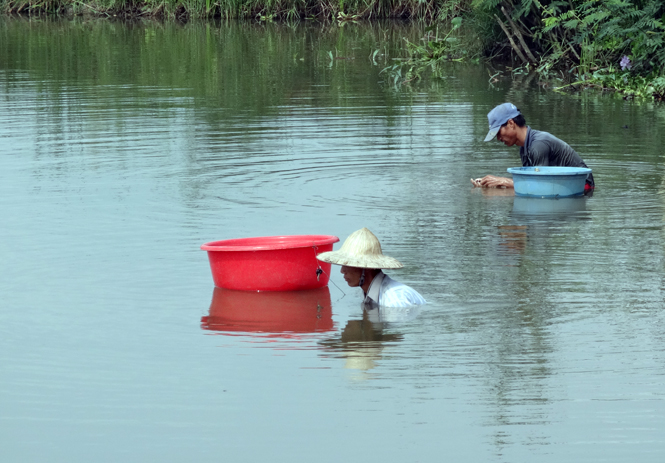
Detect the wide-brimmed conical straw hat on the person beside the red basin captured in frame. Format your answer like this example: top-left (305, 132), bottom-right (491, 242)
top-left (316, 228), bottom-right (403, 268)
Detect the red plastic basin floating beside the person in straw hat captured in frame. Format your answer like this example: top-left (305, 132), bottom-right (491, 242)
top-left (201, 235), bottom-right (339, 291)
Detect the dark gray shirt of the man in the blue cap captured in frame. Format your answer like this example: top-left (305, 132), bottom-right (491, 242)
top-left (520, 127), bottom-right (594, 186)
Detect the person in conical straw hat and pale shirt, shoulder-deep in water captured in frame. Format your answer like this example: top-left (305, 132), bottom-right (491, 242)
top-left (316, 228), bottom-right (425, 308)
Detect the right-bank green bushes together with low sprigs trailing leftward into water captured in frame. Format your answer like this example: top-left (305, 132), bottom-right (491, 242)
top-left (390, 0), bottom-right (665, 99)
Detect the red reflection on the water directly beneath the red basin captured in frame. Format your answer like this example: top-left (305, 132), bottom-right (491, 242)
top-left (201, 286), bottom-right (335, 337)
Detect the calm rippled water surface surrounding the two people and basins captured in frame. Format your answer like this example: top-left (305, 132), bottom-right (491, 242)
top-left (0, 16), bottom-right (665, 463)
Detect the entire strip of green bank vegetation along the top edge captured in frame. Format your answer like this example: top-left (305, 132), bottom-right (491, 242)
top-left (0, 0), bottom-right (665, 99)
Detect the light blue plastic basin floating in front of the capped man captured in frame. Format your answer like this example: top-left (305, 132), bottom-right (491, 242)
top-left (508, 166), bottom-right (591, 198)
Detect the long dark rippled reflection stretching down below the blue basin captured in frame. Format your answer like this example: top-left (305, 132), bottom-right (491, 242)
top-left (483, 196), bottom-right (591, 442)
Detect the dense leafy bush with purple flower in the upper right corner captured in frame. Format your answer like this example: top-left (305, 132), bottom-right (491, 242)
top-left (472, 0), bottom-right (665, 97)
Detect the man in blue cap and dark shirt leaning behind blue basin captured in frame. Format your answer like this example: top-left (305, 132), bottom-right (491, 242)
top-left (471, 103), bottom-right (594, 193)
